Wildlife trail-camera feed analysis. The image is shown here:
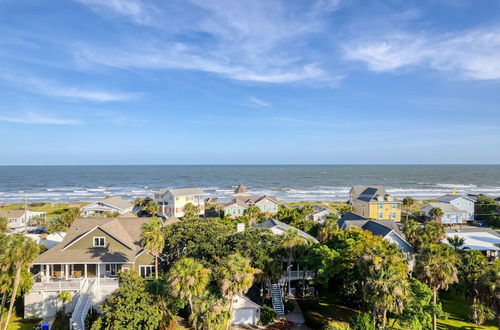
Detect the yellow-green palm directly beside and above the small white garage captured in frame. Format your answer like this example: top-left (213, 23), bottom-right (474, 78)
top-left (216, 253), bottom-right (260, 328)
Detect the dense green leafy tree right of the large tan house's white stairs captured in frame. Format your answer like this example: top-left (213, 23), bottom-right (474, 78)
top-left (92, 271), bottom-right (162, 330)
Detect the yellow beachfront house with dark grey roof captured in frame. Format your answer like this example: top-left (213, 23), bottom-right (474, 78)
top-left (353, 187), bottom-right (401, 221)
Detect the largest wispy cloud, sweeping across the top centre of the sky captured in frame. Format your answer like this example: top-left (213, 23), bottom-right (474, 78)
top-left (74, 0), bottom-right (340, 83)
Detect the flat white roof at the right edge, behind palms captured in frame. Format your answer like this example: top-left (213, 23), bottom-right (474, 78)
top-left (442, 228), bottom-right (500, 251)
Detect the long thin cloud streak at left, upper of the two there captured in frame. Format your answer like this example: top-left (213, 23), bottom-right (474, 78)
top-left (0, 72), bottom-right (139, 102)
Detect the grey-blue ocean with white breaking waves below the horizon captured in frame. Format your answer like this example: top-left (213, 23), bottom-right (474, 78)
top-left (0, 165), bottom-right (500, 203)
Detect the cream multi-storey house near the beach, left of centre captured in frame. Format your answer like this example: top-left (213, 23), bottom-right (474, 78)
top-left (154, 188), bottom-right (205, 218)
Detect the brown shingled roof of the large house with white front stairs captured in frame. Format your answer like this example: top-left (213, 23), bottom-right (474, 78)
top-left (33, 218), bottom-right (150, 264)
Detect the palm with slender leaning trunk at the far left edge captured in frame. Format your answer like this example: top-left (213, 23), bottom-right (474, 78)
top-left (4, 233), bottom-right (39, 330)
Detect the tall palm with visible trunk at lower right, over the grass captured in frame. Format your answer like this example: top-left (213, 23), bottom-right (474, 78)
top-left (414, 244), bottom-right (459, 330)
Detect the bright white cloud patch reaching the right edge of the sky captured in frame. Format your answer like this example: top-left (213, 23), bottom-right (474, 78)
top-left (344, 26), bottom-right (500, 80)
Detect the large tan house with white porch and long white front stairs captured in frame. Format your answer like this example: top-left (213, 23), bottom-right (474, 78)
top-left (24, 218), bottom-right (155, 329)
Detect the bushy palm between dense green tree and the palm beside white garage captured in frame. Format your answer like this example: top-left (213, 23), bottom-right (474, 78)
top-left (167, 258), bottom-right (210, 313)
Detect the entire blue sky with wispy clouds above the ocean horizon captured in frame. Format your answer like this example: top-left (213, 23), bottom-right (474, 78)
top-left (0, 0), bottom-right (500, 165)
